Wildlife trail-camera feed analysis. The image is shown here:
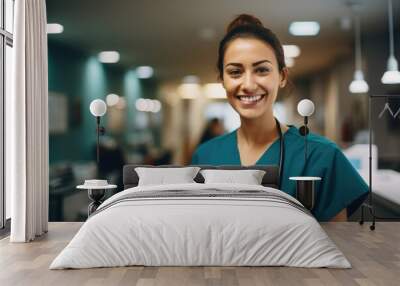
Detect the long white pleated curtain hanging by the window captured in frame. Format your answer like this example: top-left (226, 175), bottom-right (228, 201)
top-left (6, 0), bottom-right (49, 242)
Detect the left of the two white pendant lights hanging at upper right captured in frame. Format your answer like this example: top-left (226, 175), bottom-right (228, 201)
top-left (349, 15), bottom-right (369, 93)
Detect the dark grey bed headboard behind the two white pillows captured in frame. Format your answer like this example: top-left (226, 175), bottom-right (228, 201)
top-left (123, 164), bottom-right (279, 190)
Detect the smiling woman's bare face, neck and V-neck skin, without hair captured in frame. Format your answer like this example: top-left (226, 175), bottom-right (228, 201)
top-left (223, 38), bottom-right (287, 168)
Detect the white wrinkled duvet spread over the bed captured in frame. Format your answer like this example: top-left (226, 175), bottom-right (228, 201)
top-left (50, 183), bottom-right (351, 269)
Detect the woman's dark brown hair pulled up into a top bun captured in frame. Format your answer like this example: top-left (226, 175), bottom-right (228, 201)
top-left (217, 14), bottom-right (286, 79)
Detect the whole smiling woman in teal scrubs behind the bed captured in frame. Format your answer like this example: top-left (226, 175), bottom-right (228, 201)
top-left (192, 14), bottom-right (368, 220)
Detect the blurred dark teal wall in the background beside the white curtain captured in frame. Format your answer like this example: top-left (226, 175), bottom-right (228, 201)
top-left (48, 39), bottom-right (156, 164)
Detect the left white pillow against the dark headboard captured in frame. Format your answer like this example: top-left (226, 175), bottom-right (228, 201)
top-left (135, 167), bottom-right (200, 186)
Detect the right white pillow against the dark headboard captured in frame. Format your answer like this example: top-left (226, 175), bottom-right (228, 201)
top-left (200, 170), bottom-right (265, 185)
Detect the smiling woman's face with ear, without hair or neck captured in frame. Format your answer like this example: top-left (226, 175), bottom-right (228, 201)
top-left (222, 38), bottom-right (287, 119)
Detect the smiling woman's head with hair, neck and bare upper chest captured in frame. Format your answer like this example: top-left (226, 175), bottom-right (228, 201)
top-left (217, 14), bottom-right (288, 168)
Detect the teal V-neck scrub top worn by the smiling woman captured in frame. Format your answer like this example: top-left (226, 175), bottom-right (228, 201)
top-left (191, 126), bottom-right (368, 221)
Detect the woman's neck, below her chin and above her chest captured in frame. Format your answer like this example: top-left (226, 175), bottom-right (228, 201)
top-left (238, 114), bottom-right (288, 147)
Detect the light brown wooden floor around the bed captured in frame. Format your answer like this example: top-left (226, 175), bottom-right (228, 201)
top-left (0, 222), bottom-right (400, 286)
